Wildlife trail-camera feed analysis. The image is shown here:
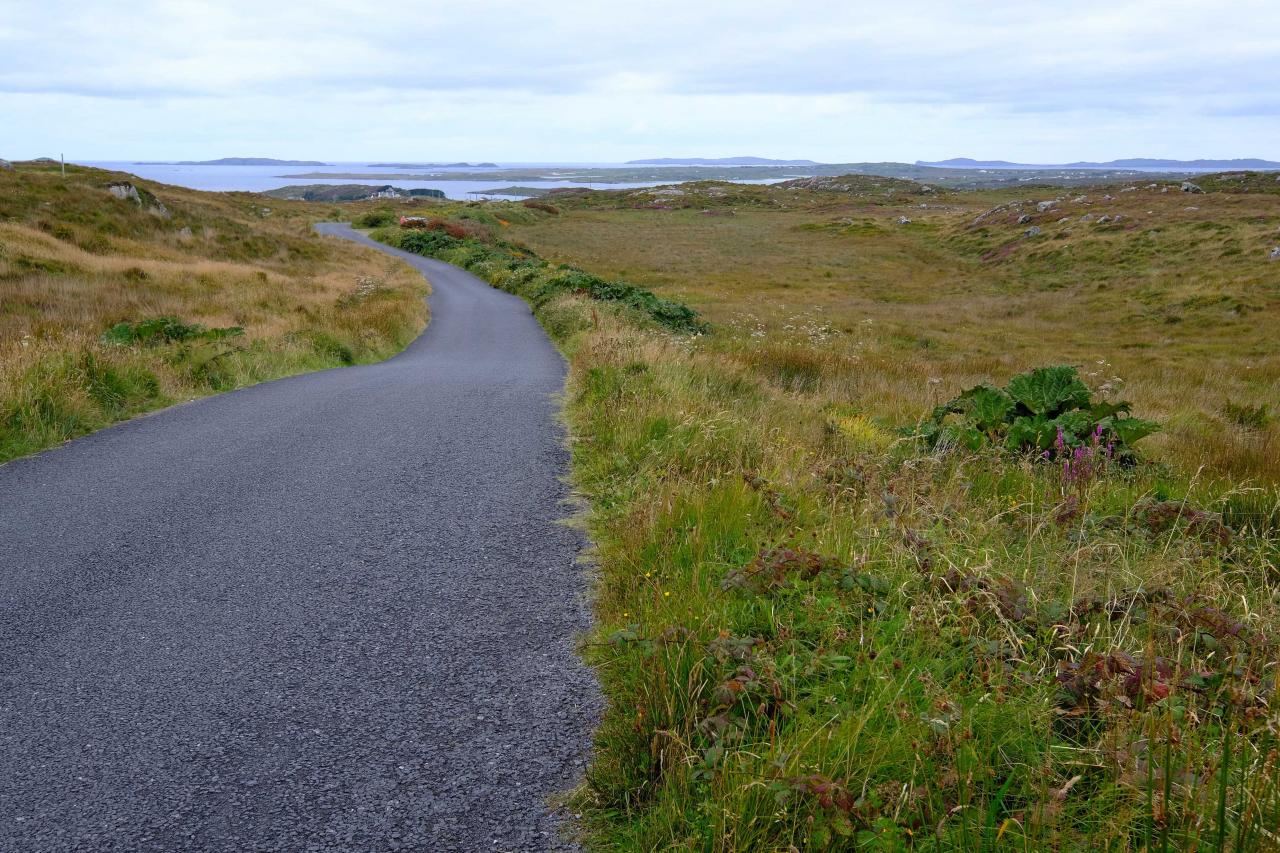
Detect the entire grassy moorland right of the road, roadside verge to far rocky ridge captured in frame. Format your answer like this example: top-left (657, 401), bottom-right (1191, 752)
top-left (381, 178), bottom-right (1280, 850)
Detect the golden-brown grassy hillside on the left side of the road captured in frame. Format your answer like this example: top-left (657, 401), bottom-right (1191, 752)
top-left (0, 164), bottom-right (426, 462)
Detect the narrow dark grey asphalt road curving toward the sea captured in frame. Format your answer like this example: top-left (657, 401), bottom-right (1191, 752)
top-left (0, 225), bottom-right (598, 853)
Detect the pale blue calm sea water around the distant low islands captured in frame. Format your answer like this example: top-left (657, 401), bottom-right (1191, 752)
top-left (83, 160), bottom-right (772, 199)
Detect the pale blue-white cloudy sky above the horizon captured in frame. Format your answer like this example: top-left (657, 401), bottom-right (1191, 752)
top-left (0, 0), bottom-right (1280, 163)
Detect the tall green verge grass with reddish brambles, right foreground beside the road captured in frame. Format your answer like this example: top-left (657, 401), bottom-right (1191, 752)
top-left (560, 324), bottom-right (1280, 850)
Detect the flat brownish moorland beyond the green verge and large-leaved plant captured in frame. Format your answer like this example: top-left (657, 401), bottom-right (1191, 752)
top-left (513, 183), bottom-right (1280, 484)
